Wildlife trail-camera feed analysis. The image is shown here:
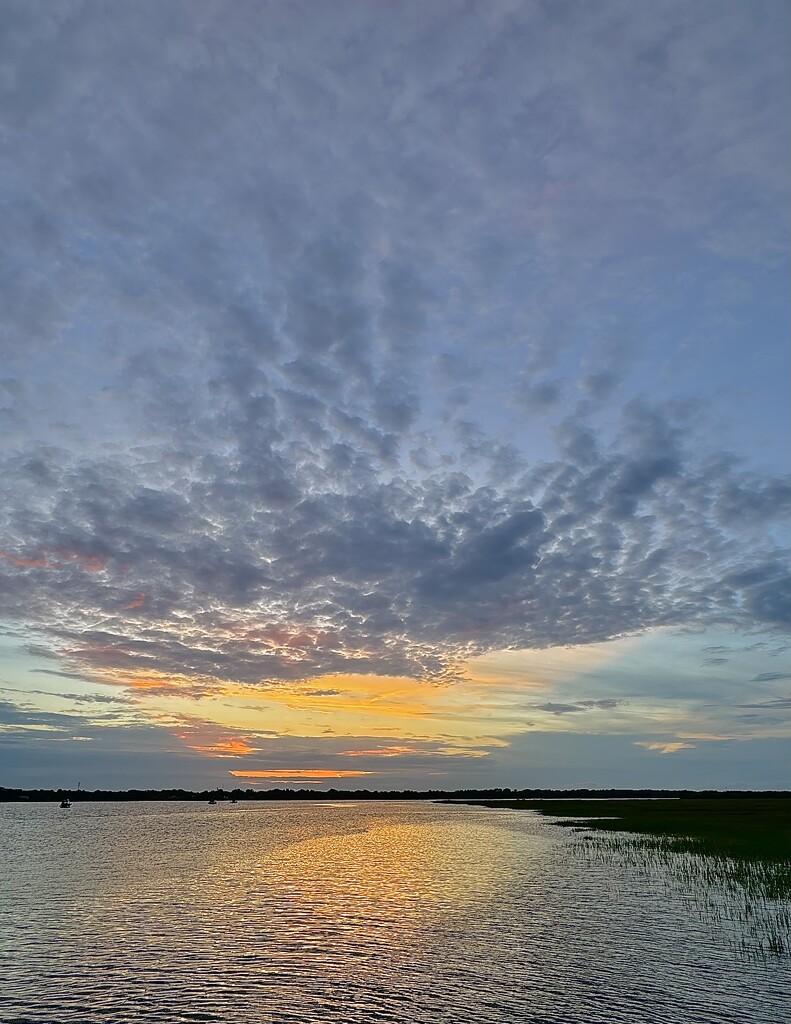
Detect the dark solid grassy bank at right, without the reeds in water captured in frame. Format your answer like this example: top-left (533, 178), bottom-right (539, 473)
top-left (450, 797), bottom-right (791, 863)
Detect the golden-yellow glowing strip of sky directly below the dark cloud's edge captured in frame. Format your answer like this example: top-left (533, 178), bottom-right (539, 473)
top-left (75, 644), bottom-right (635, 757)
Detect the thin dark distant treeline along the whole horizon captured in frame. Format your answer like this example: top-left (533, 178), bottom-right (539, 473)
top-left (0, 786), bottom-right (791, 802)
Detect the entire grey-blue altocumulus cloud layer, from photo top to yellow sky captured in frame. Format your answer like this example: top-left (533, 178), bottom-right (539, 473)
top-left (0, 0), bottom-right (789, 696)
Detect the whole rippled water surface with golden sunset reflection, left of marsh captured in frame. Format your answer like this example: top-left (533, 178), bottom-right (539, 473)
top-left (0, 802), bottom-right (788, 1024)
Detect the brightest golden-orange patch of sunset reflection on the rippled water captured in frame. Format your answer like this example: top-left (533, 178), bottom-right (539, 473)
top-left (209, 808), bottom-right (543, 970)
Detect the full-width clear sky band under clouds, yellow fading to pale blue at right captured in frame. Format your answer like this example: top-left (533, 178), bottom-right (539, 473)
top-left (0, 631), bottom-right (785, 784)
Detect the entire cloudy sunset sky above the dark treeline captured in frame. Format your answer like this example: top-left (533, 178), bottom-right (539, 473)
top-left (0, 0), bottom-right (791, 790)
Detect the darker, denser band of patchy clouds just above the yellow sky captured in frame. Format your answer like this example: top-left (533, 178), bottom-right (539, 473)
top-left (2, 393), bottom-right (786, 682)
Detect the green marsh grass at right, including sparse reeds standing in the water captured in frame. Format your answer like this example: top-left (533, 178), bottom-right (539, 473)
top-left (463, 797), bottom-right (791, 957)
